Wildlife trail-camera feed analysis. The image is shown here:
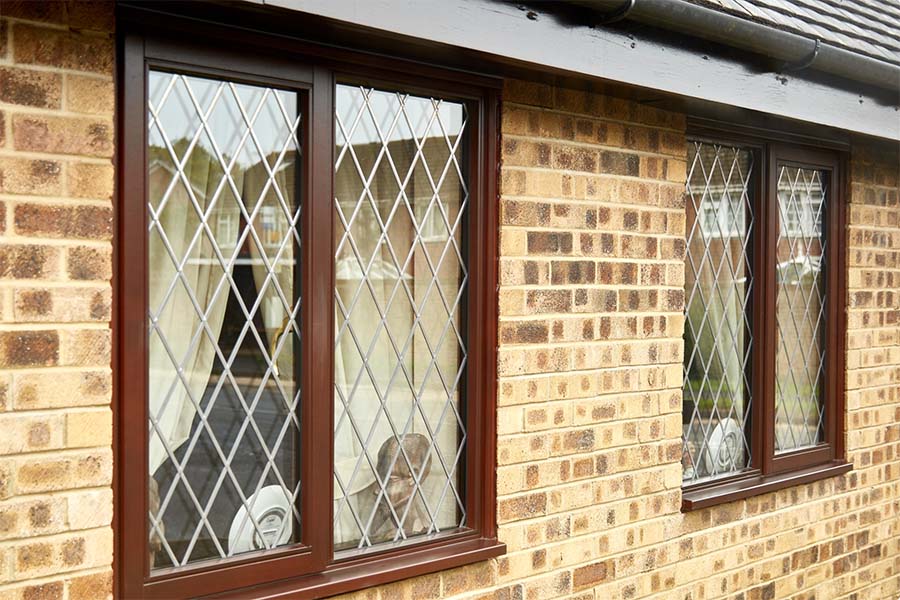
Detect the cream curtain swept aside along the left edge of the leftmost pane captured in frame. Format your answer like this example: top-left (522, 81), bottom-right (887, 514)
top-left (148, 149), bottom-right (243, 474)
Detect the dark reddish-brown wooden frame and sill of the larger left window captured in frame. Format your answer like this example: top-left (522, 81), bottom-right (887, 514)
top-left (113, 9), bottom-right (505, 598)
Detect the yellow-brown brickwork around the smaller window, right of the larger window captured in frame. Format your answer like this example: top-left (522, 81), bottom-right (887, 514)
top-left (334, 82), bottom-right (900, 600)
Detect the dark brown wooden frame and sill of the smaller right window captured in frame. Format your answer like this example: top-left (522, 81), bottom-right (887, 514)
top-left (682, 119), bottom-right (852, 512)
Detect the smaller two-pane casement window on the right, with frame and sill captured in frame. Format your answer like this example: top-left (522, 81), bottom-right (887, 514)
top-left (682, 131), bottom-right (848, 509)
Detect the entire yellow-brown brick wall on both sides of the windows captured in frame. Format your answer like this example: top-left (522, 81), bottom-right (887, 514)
top-left (0, 2), bottom-right (900, 600)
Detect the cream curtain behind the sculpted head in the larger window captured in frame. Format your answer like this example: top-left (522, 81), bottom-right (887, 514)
top-left (334, 126), bottom-right (462, 547)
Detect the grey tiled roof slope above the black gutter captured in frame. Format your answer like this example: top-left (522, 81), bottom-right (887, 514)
top-left (691, 0), bottom-right (900, 64)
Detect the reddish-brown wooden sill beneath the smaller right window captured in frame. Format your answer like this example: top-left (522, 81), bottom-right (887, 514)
top-left (681, 461), bottom-right (853, 512)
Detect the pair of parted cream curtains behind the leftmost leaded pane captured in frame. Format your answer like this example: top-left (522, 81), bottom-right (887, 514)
top-left (149, 150), bottom-right (294, 474)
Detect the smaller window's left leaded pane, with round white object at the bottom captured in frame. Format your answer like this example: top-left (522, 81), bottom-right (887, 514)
top-left (682, 142), bottom-right (755, 483)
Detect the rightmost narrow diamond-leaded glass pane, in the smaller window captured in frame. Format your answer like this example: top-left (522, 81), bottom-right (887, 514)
top-left (775, 166), bottom-right (826, 452)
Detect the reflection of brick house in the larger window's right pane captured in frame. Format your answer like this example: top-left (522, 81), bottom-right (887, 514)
top-left (334, 137), bottom-right (466, 389)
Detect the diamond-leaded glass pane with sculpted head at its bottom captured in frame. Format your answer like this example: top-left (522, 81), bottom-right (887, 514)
top-left (334, 85), bottom-right (468, 550)
